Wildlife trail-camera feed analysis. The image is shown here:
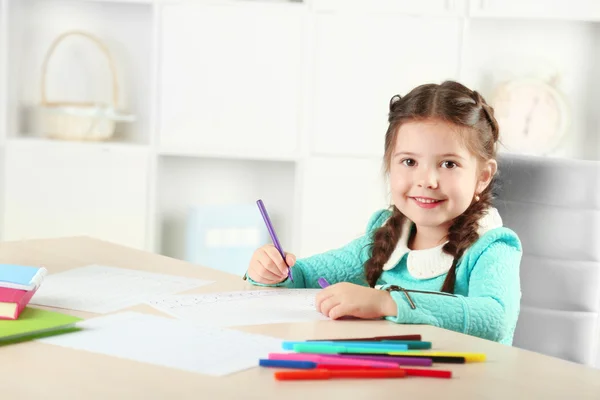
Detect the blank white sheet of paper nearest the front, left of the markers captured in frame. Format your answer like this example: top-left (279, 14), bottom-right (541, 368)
top-left (38, 311), bottom-right (282, 376)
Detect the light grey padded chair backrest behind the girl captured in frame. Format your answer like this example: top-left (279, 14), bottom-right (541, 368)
top-left (495, 154), bottom-right (600, 367)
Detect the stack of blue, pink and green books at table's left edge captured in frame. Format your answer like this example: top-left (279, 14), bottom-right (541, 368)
top-left (0, 264), bottom-right (81, 346)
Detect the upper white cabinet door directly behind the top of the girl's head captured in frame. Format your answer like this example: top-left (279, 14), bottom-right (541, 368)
top-left (312, 14), bottom-right (460, 156)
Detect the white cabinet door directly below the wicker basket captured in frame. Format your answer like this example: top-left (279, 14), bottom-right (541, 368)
top-left (3, 140), bottom-right (149, 249)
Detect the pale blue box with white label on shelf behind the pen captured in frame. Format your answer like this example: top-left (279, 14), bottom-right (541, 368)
top-left (185, 203), bottom-right (269, 276)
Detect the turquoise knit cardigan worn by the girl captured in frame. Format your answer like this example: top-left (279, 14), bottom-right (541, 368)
top-left (249, 210), bottom-right (522, 345)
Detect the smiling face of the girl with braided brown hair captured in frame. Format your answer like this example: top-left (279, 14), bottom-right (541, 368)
top-left (389, 120), bottom-right (497, 238)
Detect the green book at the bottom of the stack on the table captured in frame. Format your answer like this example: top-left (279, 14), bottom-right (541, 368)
top-left (0, 307), bottom-right (82, 346)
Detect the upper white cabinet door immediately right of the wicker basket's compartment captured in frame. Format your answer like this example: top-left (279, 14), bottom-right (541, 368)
top-left (160, 2), bottom-right (306, 158)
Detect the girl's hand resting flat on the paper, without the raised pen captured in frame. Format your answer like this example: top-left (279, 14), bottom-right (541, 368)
top-left (315, 282), bottom-right (397, 319)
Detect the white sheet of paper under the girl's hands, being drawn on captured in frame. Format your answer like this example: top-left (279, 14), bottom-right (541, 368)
top-left (148, 289), bottom-right (329, 327)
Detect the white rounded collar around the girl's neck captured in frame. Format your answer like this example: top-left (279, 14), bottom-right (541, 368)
top-left (383, 207), bottom-right (502, 279)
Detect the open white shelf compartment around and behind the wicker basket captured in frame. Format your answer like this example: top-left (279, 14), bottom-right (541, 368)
top-left (6, 0), bottom-right (154, 143)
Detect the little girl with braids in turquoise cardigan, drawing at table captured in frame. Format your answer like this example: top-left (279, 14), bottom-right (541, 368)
top-left (247, 81), bottom-right (522, 345)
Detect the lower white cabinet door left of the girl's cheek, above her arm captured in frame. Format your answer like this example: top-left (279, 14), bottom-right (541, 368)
top-left (290, 158), bottom-right (390, 257)
